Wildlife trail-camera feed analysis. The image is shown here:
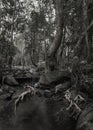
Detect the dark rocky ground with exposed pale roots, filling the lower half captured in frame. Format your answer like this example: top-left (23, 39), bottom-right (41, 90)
top-left (0, 65), bottom-right (93, 130)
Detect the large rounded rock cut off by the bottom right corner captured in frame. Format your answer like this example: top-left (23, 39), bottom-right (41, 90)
top-left (76, 102), bottom-right (93, 130)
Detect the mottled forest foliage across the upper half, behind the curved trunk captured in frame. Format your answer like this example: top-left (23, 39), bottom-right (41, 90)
top-left (0, 0), bottom-right (93, 68)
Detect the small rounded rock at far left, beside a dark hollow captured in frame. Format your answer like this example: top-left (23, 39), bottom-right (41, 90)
top-left (3, 75), bottom-right (18, 86)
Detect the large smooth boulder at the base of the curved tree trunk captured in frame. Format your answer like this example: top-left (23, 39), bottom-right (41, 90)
top-left (39, 70), bottom-right (70, 87)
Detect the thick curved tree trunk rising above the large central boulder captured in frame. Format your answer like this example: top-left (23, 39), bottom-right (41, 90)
top-left (48, 0), bottom-right (63, 70)
